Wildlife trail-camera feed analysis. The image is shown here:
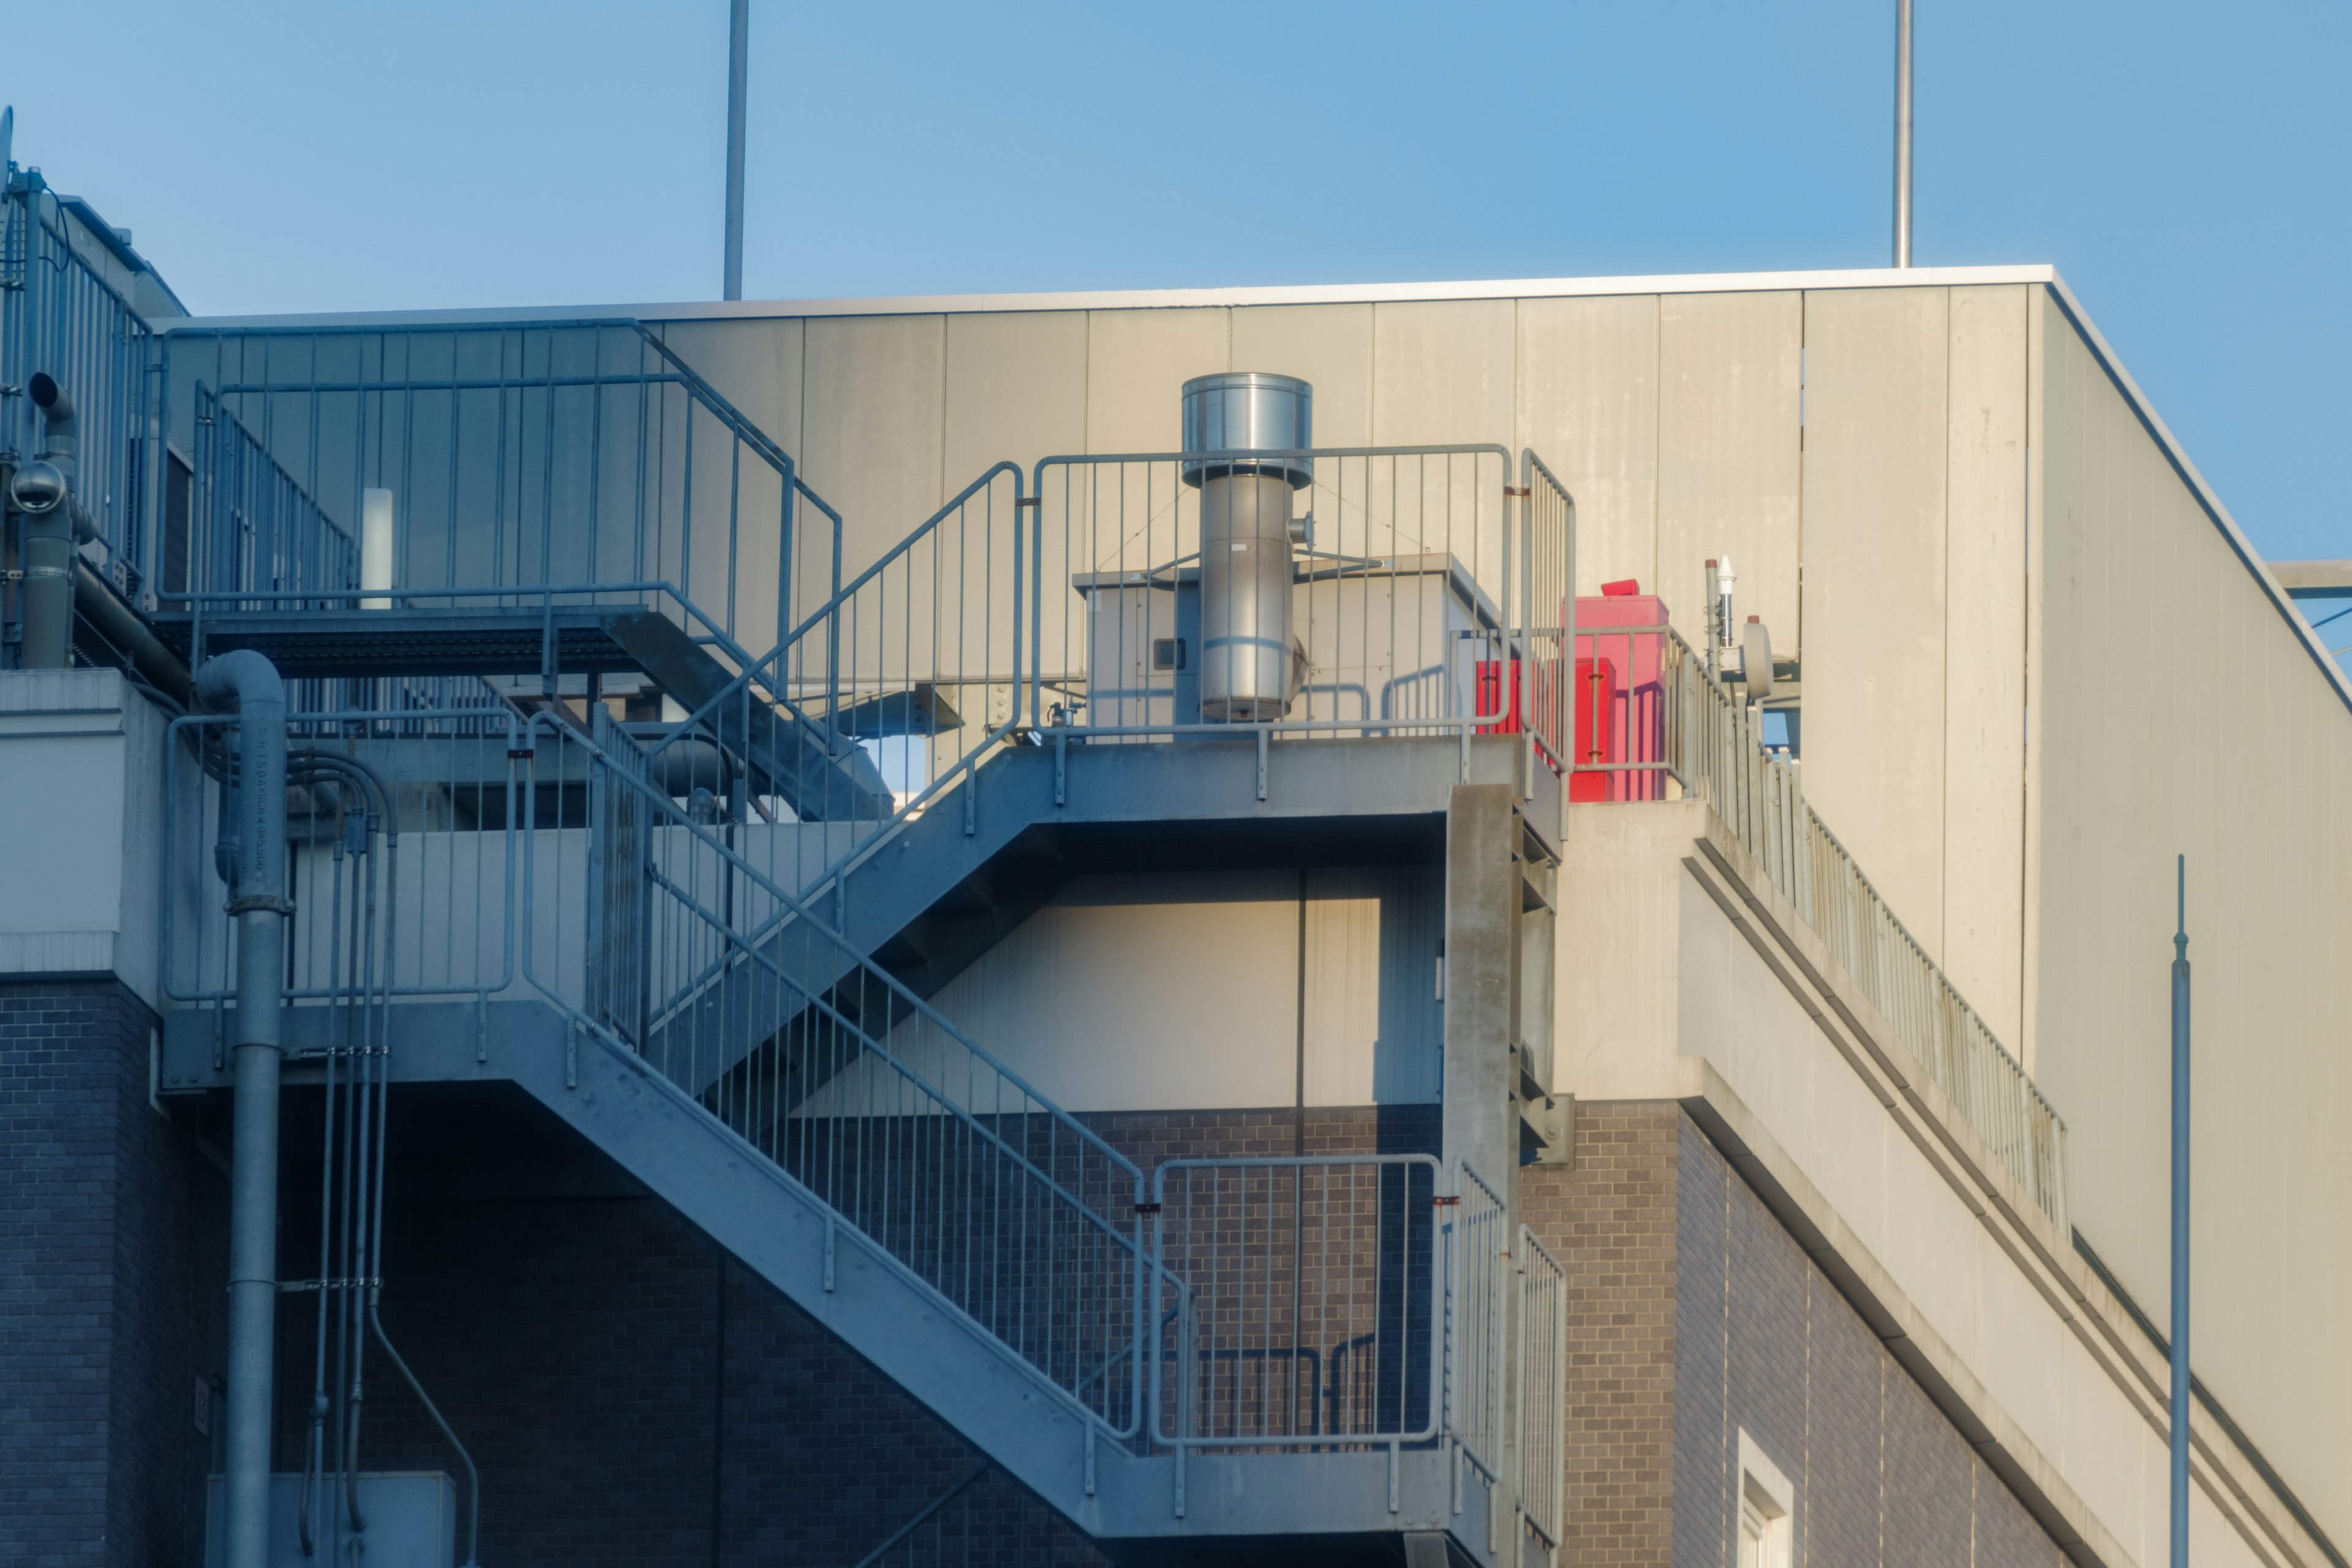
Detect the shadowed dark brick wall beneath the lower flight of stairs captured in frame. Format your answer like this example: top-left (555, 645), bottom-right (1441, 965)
top-left (277, 1189), bottom-right (1101, 1568)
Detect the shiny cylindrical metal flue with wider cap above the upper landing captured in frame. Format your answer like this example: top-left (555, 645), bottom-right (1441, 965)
top-left (1183, 371), bottom-right (1315, 724)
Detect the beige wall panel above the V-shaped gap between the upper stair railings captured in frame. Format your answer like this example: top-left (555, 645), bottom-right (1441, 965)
top-left (800, 315), bottom-right (948, 578)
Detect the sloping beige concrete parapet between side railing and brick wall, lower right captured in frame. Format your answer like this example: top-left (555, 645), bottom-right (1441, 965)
top-left (1555, 802), bottom-right (2333, 1563)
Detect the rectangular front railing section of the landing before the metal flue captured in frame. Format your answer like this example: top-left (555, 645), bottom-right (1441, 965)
top-left (1025, 447), bottom-right (1566, 741)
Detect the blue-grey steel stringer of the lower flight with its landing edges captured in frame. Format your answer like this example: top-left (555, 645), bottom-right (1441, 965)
top-left (160, 1001), bottom-right (1501, 1568)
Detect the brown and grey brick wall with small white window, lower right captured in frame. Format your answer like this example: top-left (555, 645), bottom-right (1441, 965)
top-left (1520, 1102), bottom-right (2060, 1568)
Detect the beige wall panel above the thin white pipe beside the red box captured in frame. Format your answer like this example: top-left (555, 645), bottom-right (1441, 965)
top-left (1642, 294), bottom-right (1804, 654)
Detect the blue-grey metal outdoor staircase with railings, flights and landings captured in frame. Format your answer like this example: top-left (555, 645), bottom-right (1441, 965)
top-left (129, 312), bottom-right (1566, 1563)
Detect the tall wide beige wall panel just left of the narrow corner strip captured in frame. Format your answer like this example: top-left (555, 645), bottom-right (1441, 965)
top-left (1801, 289), bottom-right (1948, 962)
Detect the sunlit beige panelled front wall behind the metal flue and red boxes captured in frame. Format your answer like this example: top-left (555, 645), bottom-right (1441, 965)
top-left (639, 275), bottom-right (2037, 1041)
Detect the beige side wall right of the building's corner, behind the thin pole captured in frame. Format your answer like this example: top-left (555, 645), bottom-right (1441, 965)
top-left (2032, 315), bottom-right (2352, 1540)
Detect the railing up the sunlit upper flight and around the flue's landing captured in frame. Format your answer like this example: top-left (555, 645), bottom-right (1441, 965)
top-left (656, 447), bottom-right (1574, 968)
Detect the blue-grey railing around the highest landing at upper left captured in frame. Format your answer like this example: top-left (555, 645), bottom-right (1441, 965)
top-left (162, 317), bottom-right (842, 663)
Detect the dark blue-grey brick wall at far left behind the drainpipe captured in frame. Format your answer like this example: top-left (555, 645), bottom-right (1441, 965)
top-left (0, 978), bottom-right (228, 1566)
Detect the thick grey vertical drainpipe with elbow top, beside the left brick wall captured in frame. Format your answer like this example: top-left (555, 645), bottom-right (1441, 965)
top-left (195, 649), bottom-right (292, 1568)
